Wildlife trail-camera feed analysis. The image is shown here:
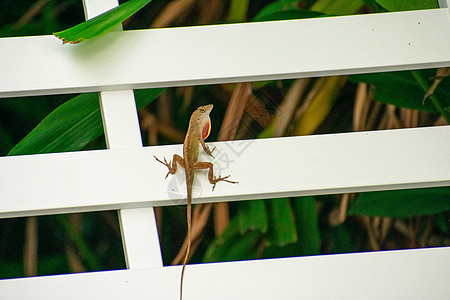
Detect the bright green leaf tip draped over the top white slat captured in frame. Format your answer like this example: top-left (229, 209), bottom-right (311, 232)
top-left (53, 0), bottom-right (151, 44)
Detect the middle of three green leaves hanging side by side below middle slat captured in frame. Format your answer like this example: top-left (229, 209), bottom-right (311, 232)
top-left (265, 198), bottom-right (298, 246)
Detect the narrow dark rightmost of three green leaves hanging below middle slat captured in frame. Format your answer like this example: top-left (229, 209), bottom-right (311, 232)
top-left (294, 196), bottom-right (320, 255)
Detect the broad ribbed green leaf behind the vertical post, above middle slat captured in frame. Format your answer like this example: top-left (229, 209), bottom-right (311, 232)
top-left (8, 89), bottom-right (164, 155)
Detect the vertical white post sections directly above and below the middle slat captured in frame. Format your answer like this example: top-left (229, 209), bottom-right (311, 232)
top-left (99, 90), bottom-right (162, 269)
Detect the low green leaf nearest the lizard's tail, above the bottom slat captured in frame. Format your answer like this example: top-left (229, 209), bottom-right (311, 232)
top-left (203, 217), bottom-right (262, 262)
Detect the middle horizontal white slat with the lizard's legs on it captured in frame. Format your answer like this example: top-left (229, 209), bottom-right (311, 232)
top-left (0, 126), bottom-right (450, 217)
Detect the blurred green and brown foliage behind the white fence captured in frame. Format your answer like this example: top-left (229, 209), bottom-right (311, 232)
top-left (0, 0), bottom-right (450, 278)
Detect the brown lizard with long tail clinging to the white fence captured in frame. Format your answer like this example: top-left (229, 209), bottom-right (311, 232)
top-left (155, 104), bottom-right (237, 300)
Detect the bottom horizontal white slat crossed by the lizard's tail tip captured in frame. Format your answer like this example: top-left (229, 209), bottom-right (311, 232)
top-left (0, 248), bottom-right (450, 300)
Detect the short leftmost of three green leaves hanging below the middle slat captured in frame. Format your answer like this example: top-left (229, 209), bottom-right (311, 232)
top-left (238, 200), bottom-right (269, 234)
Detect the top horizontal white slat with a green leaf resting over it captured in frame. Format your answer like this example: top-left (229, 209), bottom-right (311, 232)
top-left (0, 9), bottom-right (450, 97)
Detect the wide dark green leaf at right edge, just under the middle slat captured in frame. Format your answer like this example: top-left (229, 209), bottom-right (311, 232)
top-left (348, 187), bottom-right (450, 218)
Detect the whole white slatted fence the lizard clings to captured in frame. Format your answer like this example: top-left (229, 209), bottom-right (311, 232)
top-left (0, 0), bottom-right (450, 299)
